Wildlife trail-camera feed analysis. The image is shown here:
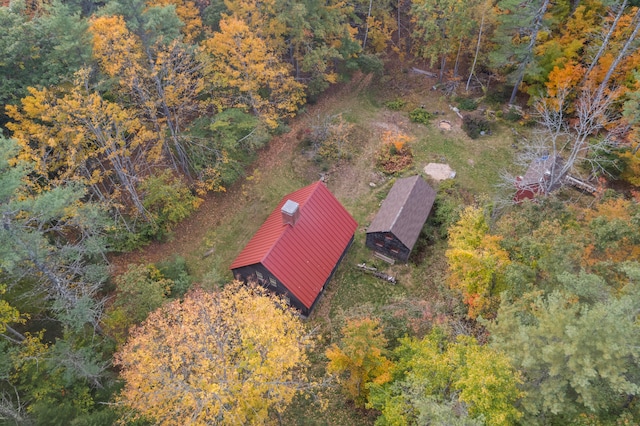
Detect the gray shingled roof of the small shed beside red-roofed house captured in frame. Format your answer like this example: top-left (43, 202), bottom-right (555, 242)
top-left (367, 176), bottom-right (436, 250)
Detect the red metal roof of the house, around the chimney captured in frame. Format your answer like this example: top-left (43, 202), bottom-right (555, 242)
top-left (231, 181), bottom-right (358, 308)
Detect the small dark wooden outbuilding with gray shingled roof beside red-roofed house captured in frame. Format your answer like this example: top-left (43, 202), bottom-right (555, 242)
top-left (366, 176), bottom-right (436, 262)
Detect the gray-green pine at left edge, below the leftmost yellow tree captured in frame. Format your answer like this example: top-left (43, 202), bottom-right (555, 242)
top-left (0, 138), bottom-right (107, 329)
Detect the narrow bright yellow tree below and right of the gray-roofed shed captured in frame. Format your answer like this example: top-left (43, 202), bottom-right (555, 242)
top-left (446, 207), bottom-right (510, 318)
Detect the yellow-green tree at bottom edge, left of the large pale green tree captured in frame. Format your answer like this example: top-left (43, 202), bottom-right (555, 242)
top-left (368, 329), bottom-right (522, 425)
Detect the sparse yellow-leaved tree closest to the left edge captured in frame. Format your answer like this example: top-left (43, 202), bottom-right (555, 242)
top-left (7, 68), bottom-right (153, 223)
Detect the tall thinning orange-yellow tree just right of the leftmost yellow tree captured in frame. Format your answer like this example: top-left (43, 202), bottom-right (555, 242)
top-left (89, 16), bottom-right (208, 185)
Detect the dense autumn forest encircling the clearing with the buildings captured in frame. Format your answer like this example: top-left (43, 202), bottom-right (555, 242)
top-left (0, 0), bottom-right (640, 425)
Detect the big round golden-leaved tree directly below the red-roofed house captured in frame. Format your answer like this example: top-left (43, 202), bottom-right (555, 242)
top-left (115, 282), bottom-right (313, 425)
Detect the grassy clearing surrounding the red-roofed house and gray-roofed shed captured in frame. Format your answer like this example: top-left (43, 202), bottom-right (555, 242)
top-left (164, 71), bottom-right (513, 425)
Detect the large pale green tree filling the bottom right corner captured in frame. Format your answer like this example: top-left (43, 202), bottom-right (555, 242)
top-left (489, 286), bottom-right (640, 424)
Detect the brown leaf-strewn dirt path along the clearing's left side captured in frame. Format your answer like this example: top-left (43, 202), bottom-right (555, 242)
top-left (109, 76), bottom-right (371, 275)
